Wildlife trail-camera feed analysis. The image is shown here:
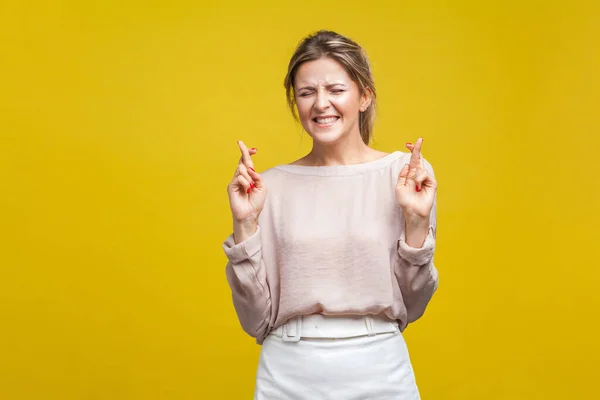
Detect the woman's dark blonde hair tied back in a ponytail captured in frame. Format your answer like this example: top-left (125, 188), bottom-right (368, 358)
top-left (283, 30), bottom-right (376, 145)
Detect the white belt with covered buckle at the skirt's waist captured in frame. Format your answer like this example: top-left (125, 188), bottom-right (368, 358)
top-left (271, 314), bottom-right (399, 342)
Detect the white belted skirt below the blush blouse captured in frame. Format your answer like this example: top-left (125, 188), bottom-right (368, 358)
top-left (254, 315), bottom-right (420, 400)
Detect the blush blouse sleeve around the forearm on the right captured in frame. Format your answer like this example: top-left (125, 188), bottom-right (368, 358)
top-left (396, 161), bottom-right (438, 324)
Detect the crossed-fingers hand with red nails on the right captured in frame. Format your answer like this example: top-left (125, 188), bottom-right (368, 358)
top-left (396, 138), bottom-right (437, 220)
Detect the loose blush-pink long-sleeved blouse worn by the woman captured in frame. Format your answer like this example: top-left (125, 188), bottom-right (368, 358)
top-left (223, 151), bottom-right (437, 344)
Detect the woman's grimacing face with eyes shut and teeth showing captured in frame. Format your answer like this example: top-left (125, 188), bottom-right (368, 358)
top-left (294, 58), bottom-right (370, 143)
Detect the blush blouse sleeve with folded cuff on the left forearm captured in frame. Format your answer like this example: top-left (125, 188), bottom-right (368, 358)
top-left (223, 227), bottom-right (271, 342)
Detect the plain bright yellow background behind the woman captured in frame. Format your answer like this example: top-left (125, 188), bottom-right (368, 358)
top-left (0, 0), bottom-right (600, 400)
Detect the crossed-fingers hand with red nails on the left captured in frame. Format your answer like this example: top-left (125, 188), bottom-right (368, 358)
top-left (227, 141), bottom-right (267, 243)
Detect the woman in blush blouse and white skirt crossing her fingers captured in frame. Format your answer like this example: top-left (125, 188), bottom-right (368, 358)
top-left (223, 31), bottom-right (437, 400)
